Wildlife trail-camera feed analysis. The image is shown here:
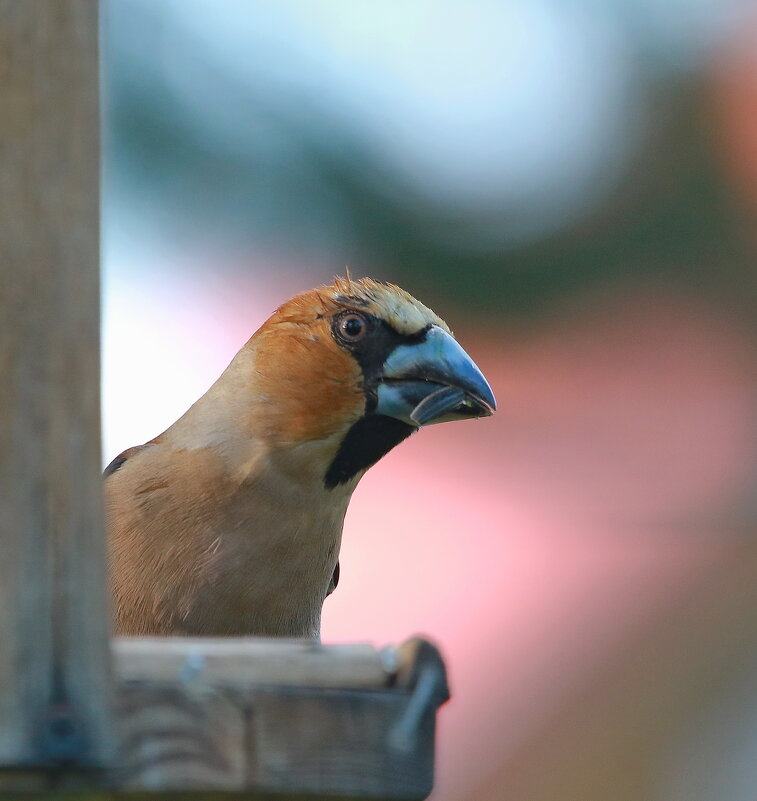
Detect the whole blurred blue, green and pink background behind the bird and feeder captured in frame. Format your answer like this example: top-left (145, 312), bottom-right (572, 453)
top-left (103, 0), bottom-right (757, 801)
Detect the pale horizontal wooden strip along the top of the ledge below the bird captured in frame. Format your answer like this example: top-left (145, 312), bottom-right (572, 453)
top-left (112, 637), bottom-right (394, 689)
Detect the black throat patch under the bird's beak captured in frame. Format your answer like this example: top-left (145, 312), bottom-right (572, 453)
top-left (324, 414), bottom-right (418, 489)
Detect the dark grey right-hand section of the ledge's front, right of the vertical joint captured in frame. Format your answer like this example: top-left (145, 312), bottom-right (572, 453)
top-left (248, 687), bottom-right (437, 799)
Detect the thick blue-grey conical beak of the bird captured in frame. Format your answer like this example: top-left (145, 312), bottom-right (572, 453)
top-left (375, 325), bottom-right (497, 427)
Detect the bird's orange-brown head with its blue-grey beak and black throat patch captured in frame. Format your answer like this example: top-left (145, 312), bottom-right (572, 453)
top-left (240, 278), bottom-right (496, 488)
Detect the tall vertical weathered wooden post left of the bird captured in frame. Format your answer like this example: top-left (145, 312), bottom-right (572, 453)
top-left (0, 0), bottom-right (112, 767)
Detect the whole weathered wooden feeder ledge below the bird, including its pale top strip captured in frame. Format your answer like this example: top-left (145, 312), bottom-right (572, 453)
top-left (114, 638), bottom-right (447, 801)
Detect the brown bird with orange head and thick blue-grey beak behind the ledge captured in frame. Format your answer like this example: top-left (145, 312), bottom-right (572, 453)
top-left (104, 273), bottom-right (496, 640)
